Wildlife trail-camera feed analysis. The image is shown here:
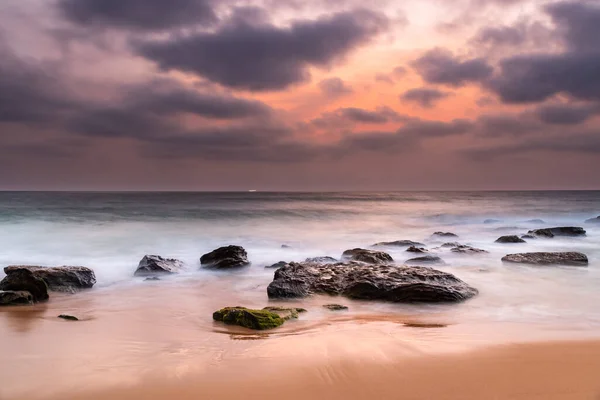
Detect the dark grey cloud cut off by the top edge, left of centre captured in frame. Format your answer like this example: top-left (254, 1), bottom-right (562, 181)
top-left (58, 0), bottom-right (217, 30)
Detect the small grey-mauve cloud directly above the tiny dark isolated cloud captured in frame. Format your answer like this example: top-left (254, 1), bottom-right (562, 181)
top-left (412, 48), bottom-right (493, 87)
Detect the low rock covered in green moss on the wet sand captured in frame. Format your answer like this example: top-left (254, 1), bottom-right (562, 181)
top-left (213, 307), bottom-right (298, 330)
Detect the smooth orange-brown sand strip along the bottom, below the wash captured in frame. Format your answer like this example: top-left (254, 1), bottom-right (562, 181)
top-left (18, 340), bottom-right (600, 400)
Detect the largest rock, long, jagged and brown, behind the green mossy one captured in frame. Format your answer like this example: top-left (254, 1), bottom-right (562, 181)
top-left (267, 262), bottom-right (477, 303)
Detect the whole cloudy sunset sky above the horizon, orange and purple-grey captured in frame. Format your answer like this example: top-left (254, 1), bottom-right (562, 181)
top-left (0, 0), bottom-right (600, 191)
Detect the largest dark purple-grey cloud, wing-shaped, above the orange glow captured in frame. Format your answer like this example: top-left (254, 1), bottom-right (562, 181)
top-left (134, 10), bottom-right (387, 90)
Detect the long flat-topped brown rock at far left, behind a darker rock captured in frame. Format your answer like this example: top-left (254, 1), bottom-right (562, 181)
top-left (4, 265), bottom-right (96, 297)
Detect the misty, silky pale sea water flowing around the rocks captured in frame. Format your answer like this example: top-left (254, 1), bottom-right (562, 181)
top-left (0, 191), bottom-right (600, 331)
